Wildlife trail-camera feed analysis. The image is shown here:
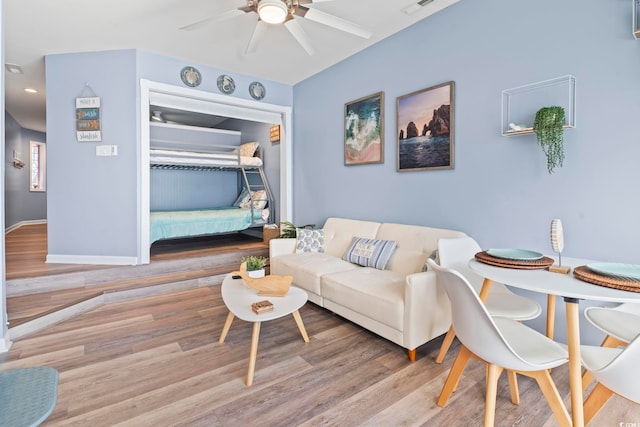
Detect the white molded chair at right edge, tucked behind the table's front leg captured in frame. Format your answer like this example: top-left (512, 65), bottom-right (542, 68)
top-left (582, 303), bottom-right (640, 391)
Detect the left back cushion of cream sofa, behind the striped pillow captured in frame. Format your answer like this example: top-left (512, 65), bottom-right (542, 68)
top-left (323, 218), bottom-right (380, 258)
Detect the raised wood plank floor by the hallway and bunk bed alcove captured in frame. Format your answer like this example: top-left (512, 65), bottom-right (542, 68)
top-left (5, 224), bottom-right (268, 328)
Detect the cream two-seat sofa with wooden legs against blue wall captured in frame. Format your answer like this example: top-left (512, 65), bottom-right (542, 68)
top-left (269, 218), bottom-right (465, 361)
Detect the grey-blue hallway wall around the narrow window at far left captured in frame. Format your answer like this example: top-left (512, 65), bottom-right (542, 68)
top-left (4, 113), bottom-right (47, 229)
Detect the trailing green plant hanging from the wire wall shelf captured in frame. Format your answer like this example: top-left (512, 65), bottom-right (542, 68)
top-left (533, 106), bottom-right (564, 173)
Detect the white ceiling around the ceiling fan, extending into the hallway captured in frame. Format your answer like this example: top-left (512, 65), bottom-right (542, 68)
top-left (4, 0), bottom-right (459, 132)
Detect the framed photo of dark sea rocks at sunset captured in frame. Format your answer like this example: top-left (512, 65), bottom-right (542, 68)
top-left (396, 81), bottom-right (455, 172)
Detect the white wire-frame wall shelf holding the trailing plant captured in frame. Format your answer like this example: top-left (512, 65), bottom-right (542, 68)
top-left (502, 75), bottom-right (576, 136)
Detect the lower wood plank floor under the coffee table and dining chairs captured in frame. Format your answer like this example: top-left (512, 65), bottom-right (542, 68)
top-left (0, 286), bottom-right (640, 426)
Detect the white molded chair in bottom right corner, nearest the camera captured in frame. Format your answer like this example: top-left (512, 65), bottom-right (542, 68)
top-left (580, 335), bottom-right (640, 424)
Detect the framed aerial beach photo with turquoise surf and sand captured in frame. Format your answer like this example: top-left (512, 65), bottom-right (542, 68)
top-left (344, 92), bottom-right (384, 166)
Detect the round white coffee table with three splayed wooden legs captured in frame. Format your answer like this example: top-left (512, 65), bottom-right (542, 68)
top-left (218, 274), bottom-right (309, 386)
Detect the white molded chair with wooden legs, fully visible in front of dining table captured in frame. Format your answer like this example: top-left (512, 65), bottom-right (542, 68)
top-left (427, 259), bottom-right (571, 427)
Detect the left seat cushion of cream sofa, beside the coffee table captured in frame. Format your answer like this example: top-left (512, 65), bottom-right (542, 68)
top-left (270, 252), bottom-right (361, 295)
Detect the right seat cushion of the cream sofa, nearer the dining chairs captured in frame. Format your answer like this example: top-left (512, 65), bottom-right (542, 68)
top-left (321, 267), bottom-right (405, 331)
